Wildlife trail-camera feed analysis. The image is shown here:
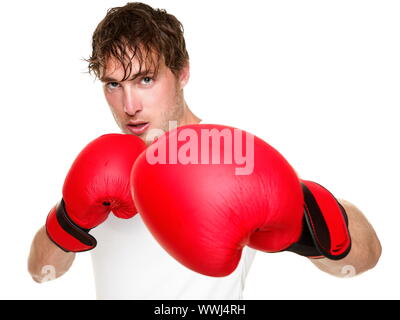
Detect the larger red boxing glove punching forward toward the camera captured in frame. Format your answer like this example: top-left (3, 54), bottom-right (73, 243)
top-left (131, 125), bottom-right (347, 277)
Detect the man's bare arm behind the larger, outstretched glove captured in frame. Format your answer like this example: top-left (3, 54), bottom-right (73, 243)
top-left (310, 199), bottom-right (382, 277)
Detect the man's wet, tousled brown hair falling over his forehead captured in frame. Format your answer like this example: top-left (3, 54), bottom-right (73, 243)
top-left (86, 2), bottom-right (189, 81)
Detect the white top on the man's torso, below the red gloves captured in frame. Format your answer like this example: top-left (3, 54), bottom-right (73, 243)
top-left (91, 214), bottom-right (255, 300)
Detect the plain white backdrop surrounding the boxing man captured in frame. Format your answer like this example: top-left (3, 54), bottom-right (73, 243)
top-left (0, 0), bottom-right (400, 299)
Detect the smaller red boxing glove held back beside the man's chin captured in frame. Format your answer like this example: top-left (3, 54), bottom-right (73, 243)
top-left (46, 134), bottom-right (146, 252)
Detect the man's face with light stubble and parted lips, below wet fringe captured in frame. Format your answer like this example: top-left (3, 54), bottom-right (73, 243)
top-left (101, 53), bottom-right (189, 143)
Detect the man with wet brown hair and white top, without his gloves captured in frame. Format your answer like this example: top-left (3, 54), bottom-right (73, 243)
top-left (29, 3), bottom-right (381, 299)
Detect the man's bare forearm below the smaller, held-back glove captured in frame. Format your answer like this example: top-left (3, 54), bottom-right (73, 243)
top-left (28, 227), bottom-right (75, 283)
